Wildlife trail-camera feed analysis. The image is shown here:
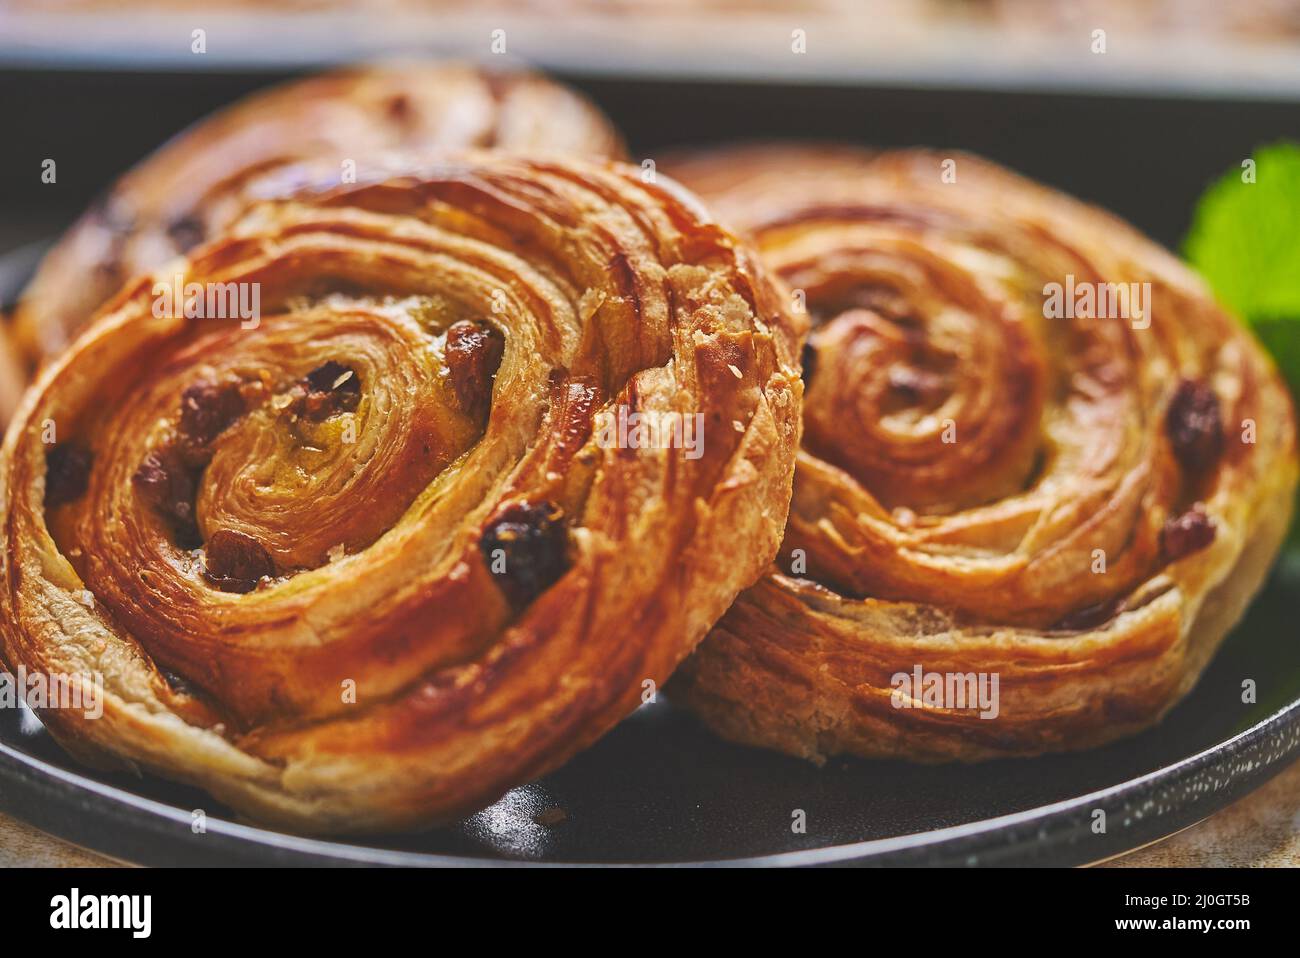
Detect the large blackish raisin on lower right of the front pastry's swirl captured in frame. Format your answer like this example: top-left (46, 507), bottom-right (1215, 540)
top-left (478, 502), bottom-right (568, 608)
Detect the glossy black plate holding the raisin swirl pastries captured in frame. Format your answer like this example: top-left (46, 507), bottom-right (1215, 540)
top-left (0, 231), bottom-right (1300, 866)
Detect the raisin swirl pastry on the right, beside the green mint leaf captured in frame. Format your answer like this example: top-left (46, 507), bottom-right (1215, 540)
top-left (663, 146), bottom-right (1296, 760)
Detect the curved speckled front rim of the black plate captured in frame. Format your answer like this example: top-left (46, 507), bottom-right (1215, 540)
top-left (0, 699), bottom-right (1300, 867)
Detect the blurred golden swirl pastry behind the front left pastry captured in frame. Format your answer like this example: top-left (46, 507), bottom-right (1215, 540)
top-left (13, 62), bottom-right (623, 364)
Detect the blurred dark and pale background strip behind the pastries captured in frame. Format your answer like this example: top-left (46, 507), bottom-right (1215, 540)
top-left (0, 0), bottom-right (1300, 252)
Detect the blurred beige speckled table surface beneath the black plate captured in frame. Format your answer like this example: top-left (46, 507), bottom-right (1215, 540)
top-left (0, 763), bottom-right (1300, 867)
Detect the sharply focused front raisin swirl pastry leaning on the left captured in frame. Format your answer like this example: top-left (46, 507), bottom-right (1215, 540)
top-left (0, 153), bottom-right (802, 832)
